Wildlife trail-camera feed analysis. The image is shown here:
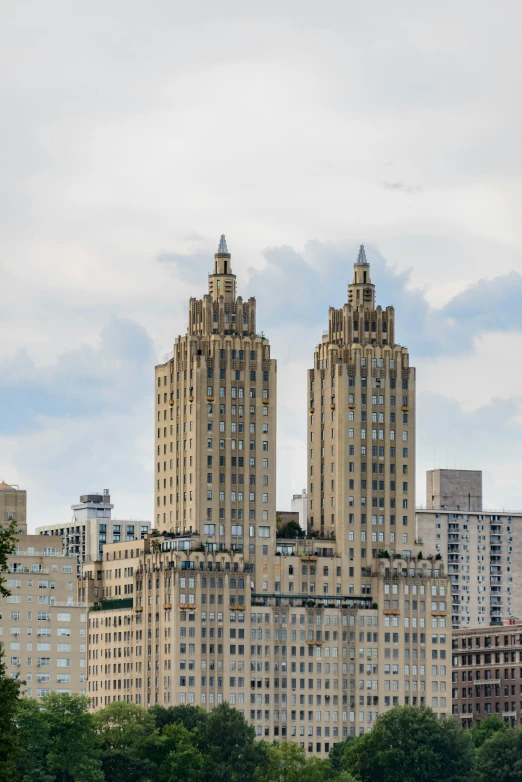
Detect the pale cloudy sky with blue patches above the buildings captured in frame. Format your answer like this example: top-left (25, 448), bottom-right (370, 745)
top-left (0, 0), bottom-right (522, 526)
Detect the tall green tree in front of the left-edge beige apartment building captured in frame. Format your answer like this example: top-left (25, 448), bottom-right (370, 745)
top-left (42, 693), bottom-right (103, 782)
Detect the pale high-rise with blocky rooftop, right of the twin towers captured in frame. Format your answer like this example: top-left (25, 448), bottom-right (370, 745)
top-left (416, 470), bottom-right (522, 629)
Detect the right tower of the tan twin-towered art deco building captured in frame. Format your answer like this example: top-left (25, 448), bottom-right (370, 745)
top-left (308, 245), bottom-right (415, 595)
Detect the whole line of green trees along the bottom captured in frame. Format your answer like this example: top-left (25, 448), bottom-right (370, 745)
top-left (0, 684), bottom-right (522, 782)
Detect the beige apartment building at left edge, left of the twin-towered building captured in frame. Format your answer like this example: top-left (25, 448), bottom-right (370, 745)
top-left (0, 484), bottom-right (88, 698)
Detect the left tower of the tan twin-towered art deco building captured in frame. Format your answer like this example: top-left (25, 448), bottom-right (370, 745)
top-left (155, 236), bottom-right (276, 561)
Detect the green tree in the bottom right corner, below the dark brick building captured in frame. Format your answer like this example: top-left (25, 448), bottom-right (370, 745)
top-left (476, 728), bottom-right (522, 782)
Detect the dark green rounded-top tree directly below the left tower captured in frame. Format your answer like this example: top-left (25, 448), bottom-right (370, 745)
top-left (198, 703), bottom-right (263, 782)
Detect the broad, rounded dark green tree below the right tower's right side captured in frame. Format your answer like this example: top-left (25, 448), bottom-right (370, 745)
top-left (343, 706), bottom-right (473, 782)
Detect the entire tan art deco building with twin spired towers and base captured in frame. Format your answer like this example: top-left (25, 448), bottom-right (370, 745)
top-left (89, 237), bottom-right (451, 756)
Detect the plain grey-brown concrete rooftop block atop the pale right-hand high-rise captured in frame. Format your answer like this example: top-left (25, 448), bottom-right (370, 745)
top-left (426, 470), bottom-right (482, 512)
